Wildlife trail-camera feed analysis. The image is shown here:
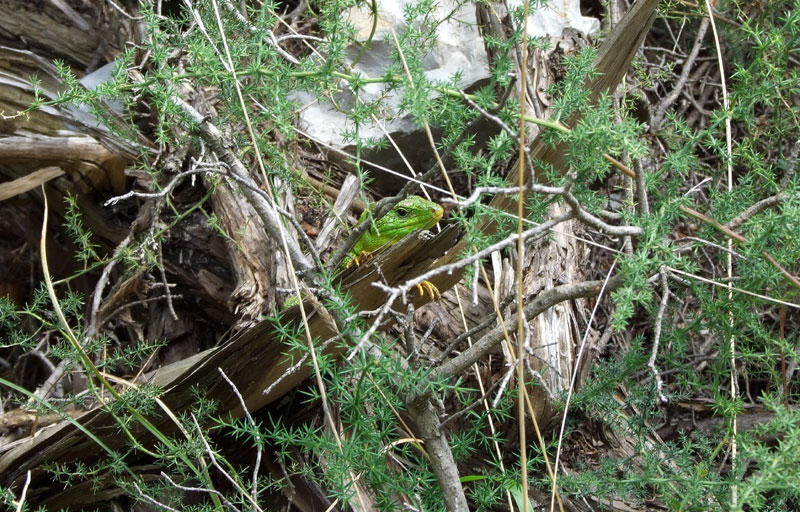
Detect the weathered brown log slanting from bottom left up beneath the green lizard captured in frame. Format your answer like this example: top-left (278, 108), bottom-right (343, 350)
top-left (0, 224), bottom-right (458, 509)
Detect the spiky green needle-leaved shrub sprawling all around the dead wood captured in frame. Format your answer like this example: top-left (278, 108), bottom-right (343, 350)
top-left (0, 0), bottom-right (800, 511)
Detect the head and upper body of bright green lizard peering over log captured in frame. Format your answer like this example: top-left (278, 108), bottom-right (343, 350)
top-left (340, 196), bottom-right (444, 268)
